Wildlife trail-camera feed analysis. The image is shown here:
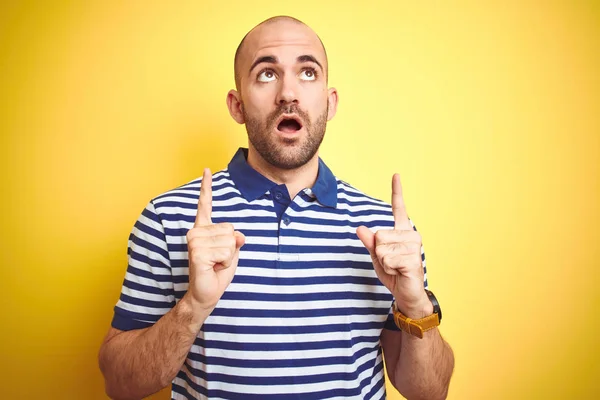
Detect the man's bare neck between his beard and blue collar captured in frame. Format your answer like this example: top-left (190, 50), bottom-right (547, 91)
top-left (248, 144), bottom-right (319, 199)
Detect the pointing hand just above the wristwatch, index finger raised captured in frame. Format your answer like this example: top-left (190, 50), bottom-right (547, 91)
top-left (356, 174), bottom-right (433, 319)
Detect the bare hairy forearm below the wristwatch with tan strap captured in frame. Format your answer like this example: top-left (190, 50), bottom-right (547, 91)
top-left (381, 328), bottom-right (454, 400)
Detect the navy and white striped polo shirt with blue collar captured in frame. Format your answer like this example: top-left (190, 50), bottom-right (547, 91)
top-left (112, 149), bottom-right (425, 400)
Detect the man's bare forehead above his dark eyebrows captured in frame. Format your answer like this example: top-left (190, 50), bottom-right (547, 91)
top-left (242, 21), bottom-right (326, 68)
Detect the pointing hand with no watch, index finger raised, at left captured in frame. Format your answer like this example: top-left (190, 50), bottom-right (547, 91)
top-left (186, 168), bottom-right (246, 311)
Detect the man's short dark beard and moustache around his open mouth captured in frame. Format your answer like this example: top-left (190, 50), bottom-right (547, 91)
top-left (242, 102), bottom-right (329, 170)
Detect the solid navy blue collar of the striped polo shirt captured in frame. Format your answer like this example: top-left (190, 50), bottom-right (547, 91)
top-left (227, 147), bottom-right (337, 208)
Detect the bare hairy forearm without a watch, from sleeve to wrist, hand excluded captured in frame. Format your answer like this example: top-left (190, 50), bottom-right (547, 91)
top-left (98, 294), bottom-right (212, 399)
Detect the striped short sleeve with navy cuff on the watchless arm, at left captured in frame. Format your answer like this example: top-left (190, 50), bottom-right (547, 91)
top-left (111, 202), bottom-right (175, 331)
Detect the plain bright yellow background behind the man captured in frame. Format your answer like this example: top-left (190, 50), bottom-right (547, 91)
top-left (0, 0), bottom-right (600, 399)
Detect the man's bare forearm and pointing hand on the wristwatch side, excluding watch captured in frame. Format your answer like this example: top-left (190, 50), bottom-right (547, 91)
top-left (357, 175), bottom-right (454, 400)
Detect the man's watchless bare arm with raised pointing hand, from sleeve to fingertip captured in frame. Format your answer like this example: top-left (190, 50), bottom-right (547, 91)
top-left (98, 169), bottom-right (245, 399)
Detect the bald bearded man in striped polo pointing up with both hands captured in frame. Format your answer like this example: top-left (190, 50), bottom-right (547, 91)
top-left (99, 17), bottom-right (454, 399)
